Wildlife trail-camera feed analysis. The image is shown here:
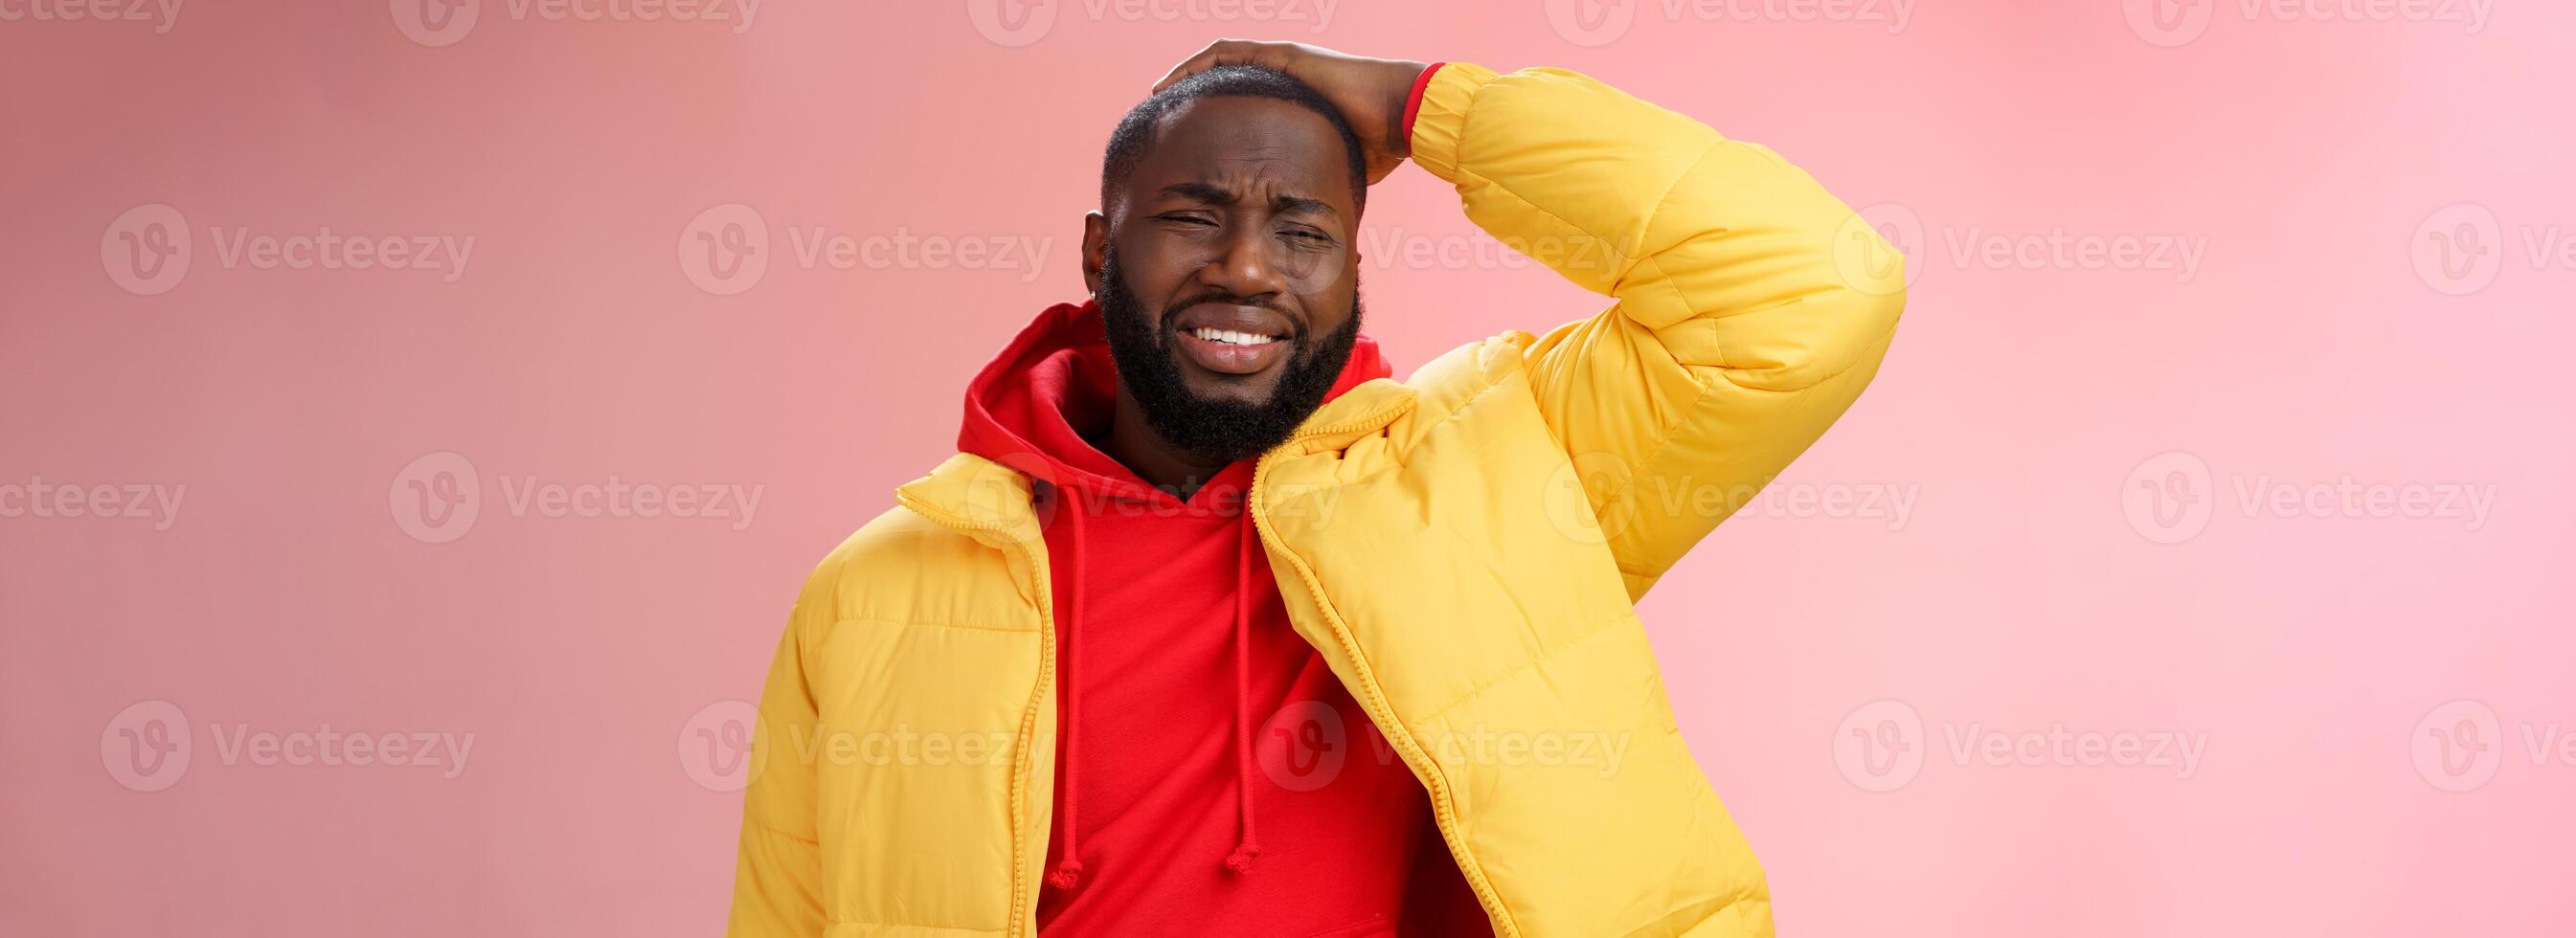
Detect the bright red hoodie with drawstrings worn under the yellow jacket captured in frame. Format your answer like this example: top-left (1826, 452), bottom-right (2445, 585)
top-left (959, 304), bottom-right (1483, 938)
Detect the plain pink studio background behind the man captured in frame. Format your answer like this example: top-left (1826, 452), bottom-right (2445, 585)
top-left (0, 0), bottom-right (2576, 935)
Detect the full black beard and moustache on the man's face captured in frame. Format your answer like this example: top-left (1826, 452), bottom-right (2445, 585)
top-left (1100, 247), bottom-right (1360, 464)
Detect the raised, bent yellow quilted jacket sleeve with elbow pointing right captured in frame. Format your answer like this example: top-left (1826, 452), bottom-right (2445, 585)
top-left (1412, 62), bottom-right (1904, 598)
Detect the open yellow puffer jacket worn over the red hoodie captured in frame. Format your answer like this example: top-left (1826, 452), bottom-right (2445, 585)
top-left (729, 62), bottom-right (1904, 938)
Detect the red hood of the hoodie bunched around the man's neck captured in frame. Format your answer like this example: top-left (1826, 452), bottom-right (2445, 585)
top-left (959, 302), bottom-right (1391, 500)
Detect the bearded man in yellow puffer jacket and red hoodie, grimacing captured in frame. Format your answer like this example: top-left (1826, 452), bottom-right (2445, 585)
top-left (729, 41), bottom-right (1904, 938)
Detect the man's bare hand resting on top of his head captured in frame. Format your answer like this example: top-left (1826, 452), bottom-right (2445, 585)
top-left (1154, 38), bottom-right (1430, 186)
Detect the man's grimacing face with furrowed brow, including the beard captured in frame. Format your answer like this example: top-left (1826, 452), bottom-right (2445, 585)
top-left (1084, 98), bottom-right (1360, 461)
